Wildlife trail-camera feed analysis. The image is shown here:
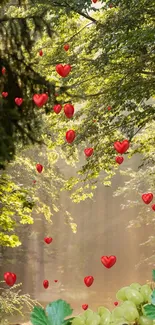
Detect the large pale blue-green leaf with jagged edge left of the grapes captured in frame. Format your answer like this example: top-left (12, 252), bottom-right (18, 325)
top-left (46, 299), bottom-right (73, 325)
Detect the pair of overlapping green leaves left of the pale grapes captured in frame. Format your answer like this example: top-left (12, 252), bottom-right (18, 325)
top-left (30, 299), bottom-right (73, 325)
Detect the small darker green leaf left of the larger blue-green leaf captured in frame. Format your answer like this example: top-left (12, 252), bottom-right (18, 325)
top-left (30, 306), bottom-right (49, 325)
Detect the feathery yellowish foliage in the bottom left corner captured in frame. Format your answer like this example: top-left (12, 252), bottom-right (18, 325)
top-left (0, 281), bottom-right (39, 325)
